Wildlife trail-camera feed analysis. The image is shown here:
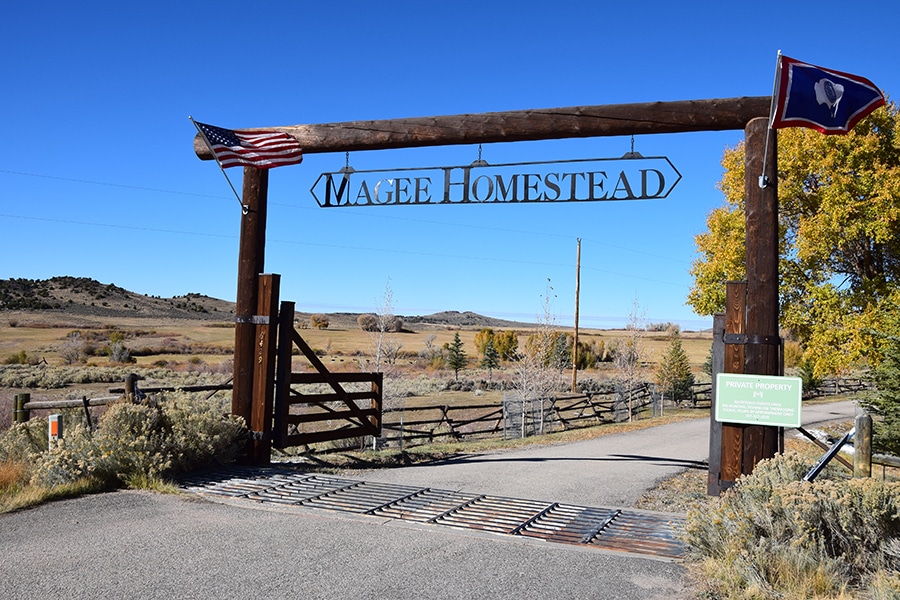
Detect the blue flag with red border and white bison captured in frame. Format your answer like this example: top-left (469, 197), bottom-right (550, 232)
top-left (769, 54), bottom-right (884, 134)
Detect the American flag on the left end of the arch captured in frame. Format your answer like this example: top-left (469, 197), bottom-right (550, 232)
top-left (194, 121), bottom-right (303, 169)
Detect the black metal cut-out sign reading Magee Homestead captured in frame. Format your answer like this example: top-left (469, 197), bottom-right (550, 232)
top-left (310, 157), bottom-right (681, 208)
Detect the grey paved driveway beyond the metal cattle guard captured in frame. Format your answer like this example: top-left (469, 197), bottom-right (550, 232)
top-left (356, 402), bottom-right (855, 507)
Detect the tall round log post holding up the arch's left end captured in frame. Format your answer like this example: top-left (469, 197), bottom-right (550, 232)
top-left (231, 167), bottom-right (269, 450)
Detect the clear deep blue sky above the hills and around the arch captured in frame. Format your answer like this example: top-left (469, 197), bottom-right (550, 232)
top-left (0, 0), bottom-right (900, 329)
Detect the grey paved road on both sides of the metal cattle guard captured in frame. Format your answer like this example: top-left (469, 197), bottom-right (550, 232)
top-left (0, 398), bottom-right (853, 600)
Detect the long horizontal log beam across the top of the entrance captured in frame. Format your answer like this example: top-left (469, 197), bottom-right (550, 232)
top-left (194, 96), bottom-right (771, 160)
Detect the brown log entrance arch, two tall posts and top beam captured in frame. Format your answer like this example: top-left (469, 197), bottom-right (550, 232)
top-left (194, 96), bottom-right (780, 493)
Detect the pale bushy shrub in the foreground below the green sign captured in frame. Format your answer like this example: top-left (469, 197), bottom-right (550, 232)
top-left (685, 455), bottom-right (900, 598)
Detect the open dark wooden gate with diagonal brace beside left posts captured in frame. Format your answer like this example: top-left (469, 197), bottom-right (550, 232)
top-left (272, 302), bottom-right (382, 448)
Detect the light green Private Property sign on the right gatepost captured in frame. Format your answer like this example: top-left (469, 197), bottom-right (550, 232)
top-left (715, 373), bottom-right (803, 427)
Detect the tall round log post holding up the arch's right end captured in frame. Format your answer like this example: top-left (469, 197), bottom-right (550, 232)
top-left (742, 118), bottom-right (782, 464)
